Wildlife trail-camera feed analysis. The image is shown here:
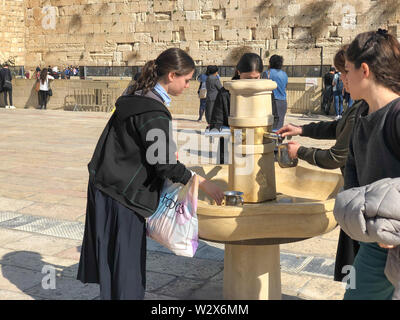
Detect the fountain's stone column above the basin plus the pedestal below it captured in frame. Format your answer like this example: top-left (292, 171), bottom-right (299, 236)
top-left (224, 80), bottom-right (281, 299)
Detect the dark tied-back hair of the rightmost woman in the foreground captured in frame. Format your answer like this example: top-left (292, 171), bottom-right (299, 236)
top-left (346, 29), bottom-right (400, 94)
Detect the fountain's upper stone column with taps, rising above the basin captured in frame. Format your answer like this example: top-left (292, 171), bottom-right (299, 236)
top-left (224, 79), bottom-right (276, 203)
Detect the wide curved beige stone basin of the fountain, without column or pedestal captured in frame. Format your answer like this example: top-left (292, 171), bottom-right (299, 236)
top-left (191, 164), bottom-right (343, 244)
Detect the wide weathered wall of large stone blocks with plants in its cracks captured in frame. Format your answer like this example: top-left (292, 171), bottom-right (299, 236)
top-left (20, 0), bottom-right (400, 68)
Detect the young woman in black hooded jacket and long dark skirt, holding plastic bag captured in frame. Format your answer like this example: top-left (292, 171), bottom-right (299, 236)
top-left (77, 48), bottom-right (224, 300)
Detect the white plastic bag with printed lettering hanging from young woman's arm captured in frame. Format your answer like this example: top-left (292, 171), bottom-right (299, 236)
top-left (147, 174), bottom-right (199, 257)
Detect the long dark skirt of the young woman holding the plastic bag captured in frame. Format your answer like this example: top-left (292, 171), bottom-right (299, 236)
top-left (77, 183), bottom-right (146, 300)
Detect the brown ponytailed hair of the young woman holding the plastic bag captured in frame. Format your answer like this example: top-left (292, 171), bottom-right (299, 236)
top-left (127, 48), bottom-right (195, 94)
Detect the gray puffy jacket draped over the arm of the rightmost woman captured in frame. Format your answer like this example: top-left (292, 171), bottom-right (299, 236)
top-left (333, 178), bottom-right (400, 299)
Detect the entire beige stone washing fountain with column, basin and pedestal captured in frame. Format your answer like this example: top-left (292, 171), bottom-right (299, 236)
top-left (191, 80), bottom-right (343, 300)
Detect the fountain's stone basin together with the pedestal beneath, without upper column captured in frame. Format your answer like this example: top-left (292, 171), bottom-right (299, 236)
top-left (191, 163), bottom-right (343, 300)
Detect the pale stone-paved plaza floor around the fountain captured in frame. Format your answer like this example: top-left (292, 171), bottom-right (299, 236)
top-left (0, 108), bottom-right (344, 300)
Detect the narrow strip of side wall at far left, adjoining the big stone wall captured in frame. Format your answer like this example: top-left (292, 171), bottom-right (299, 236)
top-left (0, 0), bottom-right (25, 66)
